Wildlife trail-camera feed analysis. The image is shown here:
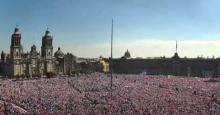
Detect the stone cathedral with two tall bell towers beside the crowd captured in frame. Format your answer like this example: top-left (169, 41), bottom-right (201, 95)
top-left (0, 26), bottom-right (76, 77)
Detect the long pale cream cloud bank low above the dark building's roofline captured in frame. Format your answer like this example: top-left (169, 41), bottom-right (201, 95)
top-left (62, 39), bottom-right (220, 58)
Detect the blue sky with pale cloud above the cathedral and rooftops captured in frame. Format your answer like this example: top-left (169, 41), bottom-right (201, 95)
top-left (0, 0), bottom-right (220, 58)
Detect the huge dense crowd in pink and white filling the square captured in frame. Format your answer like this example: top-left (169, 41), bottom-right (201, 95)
top-left (0, 73), bottom-right (220, 115)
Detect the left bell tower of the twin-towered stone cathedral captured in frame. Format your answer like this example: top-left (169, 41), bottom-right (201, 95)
top-left (10, 25), bottom-right (22, 61)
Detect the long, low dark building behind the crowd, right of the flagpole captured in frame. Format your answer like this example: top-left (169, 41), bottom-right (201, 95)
top-left (104, 45), bottom-right (220, 77)
